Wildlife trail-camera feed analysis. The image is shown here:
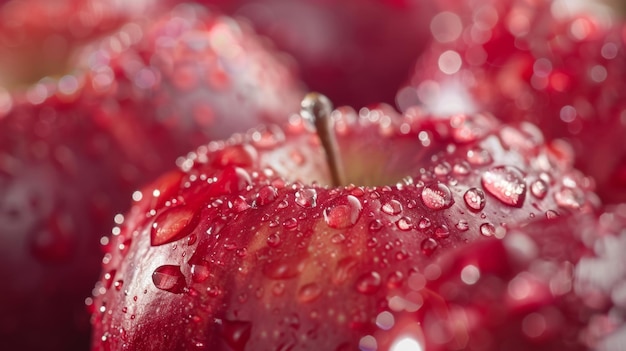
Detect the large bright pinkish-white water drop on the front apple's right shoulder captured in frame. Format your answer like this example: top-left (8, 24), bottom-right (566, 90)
top-left (482, 166), bottom-right (526, 207)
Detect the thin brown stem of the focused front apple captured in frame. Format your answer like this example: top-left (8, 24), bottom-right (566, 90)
top-left (300, 92), bottom-right (345, 186)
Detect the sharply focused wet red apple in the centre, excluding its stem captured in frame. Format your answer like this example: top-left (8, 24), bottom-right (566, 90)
top-left (91, 106), bottom-right (597, 351)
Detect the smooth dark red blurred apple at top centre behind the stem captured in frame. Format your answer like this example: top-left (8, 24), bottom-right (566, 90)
top-left (197, 0), bottom-right (437, 109)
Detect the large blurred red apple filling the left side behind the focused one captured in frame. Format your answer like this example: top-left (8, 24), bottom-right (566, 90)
top-left (0, 6), bottom-right (301, 350)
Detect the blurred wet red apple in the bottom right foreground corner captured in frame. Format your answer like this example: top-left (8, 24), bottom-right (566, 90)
top-left (372, 205), bottom-right (626, 351)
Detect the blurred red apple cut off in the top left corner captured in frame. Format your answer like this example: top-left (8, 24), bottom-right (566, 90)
top-left (0, 0), bottom-right (159, 89)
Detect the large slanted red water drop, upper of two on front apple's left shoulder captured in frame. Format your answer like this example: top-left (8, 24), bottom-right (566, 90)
top-left (150, 206), bottom-right (199, 246)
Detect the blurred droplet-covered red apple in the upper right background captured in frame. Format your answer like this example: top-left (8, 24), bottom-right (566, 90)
top-left (398, 0), bottom-right (626, 202)
